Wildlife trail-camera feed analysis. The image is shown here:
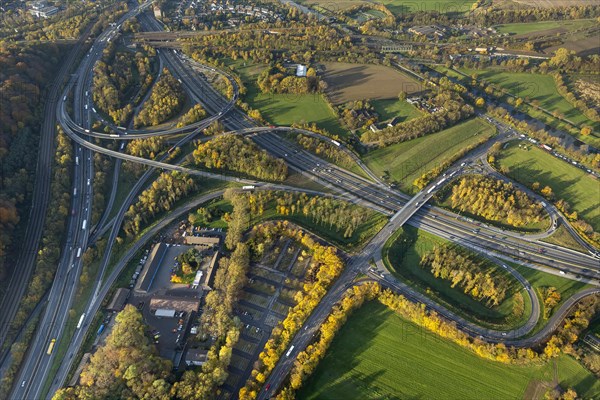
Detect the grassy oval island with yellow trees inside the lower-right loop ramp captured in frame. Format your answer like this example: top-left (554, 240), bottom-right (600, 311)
top-left (383, 225), bottom-right (532, 330)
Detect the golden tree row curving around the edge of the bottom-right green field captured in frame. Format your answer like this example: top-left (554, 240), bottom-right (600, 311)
top-left (276, 283), bottom-right (600, 400)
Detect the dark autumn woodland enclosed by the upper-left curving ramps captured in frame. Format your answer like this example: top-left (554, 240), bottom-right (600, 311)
top-left (92, 41), bottom-right (156, 125)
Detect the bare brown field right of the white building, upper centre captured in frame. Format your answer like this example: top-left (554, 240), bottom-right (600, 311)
top-left (324, 63), bottom-right (422, 104)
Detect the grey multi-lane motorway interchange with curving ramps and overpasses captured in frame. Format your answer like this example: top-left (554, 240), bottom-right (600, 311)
top-left (5, 3), bottom-right (600, 399)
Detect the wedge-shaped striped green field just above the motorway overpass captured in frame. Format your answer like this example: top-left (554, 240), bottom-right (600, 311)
top-left (364, 118), bottom-right (495, 193)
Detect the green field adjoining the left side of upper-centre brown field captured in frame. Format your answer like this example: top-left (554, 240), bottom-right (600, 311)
top-left (229, 60), bottom-right (348, 137)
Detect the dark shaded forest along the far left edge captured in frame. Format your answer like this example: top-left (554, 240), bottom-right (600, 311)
top-left (0, 44), bottom-right (66, 278)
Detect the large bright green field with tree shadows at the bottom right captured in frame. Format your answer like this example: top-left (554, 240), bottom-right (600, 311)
top-left (297, 302), bottom-right (600, 400)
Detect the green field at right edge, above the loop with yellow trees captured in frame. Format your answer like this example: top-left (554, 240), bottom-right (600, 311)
top-left (497, 142), bottom-right (600, 231)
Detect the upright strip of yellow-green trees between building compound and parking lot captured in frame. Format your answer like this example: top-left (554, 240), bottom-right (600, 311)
top-left (173, 243), bottom-right (250, 400)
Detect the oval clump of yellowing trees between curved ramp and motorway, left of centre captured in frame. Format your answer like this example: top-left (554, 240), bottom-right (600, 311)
top-left (192, 135), bottom-right (287, 181)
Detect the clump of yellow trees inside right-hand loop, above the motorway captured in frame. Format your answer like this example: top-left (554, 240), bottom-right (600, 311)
top-left (440, 175), bottom-right (546, 227)
